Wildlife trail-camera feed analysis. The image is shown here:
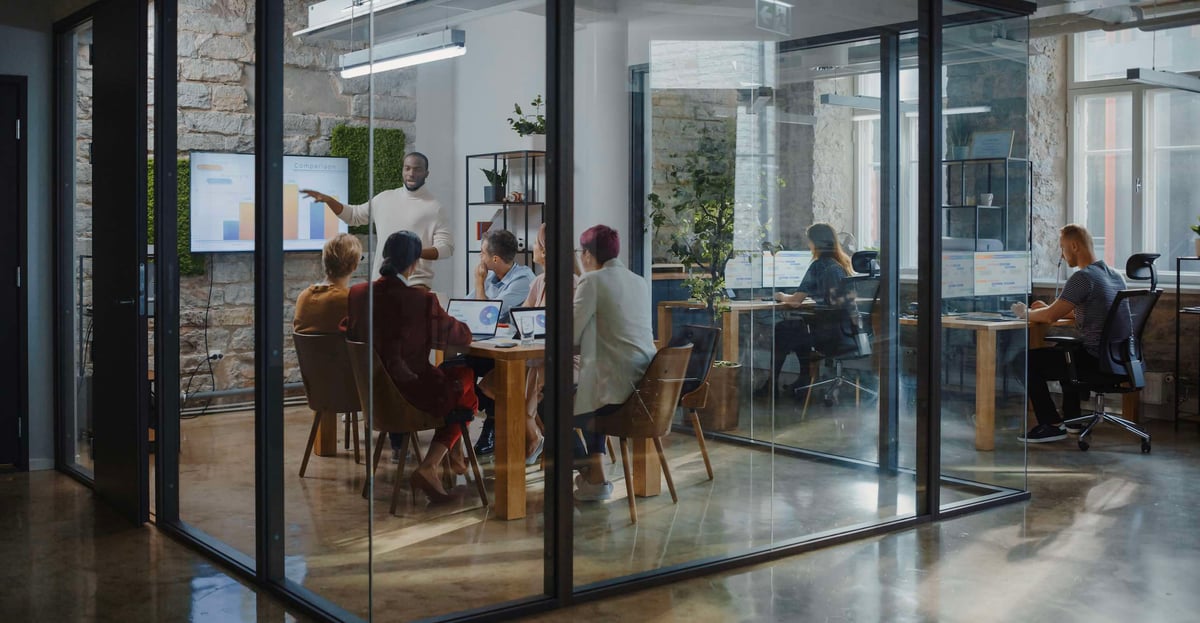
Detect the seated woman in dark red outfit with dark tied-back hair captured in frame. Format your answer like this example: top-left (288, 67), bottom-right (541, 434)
top-left (346, 230), bottom-right (479, 502)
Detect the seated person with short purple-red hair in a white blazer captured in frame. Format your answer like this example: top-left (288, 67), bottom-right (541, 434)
top-left (575, 224), bottom-right (656, 501)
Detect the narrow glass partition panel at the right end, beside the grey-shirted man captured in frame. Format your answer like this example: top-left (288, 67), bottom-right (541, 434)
top-left (940, 1), bottom-right (1027, 508)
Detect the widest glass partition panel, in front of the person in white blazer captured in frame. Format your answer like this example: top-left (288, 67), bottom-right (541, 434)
top-left (571, 2), bottom-right (916, 585)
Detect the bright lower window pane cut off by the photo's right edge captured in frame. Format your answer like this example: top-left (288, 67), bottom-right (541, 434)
top-left (1147, 91), bottom-right (1200, 270)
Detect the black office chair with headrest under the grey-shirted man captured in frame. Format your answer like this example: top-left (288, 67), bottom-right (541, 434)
top-left (1046, 253), bottom-right (1163, 454)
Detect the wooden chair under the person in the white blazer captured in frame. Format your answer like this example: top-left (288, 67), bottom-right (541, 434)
top-left (593, 343), bottom-right (691, 523)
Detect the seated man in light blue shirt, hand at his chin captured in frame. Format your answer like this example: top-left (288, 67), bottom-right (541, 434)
top-left (467, 229), bottom-right (534, 456)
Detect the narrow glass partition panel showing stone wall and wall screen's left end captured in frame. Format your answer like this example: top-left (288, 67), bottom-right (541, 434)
top-left (174, 0), bottom-right (257, 558)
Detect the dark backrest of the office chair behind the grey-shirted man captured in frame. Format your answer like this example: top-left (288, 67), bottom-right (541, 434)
top-left (1100, 289), bottom-right (1163, 389)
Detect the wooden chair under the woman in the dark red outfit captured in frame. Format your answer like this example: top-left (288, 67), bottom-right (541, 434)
top-left (346, 340), bottom-right (488, 515)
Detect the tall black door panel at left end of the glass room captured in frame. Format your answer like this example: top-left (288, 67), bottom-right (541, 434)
top-left (91, 0), bottom-right (150, 523)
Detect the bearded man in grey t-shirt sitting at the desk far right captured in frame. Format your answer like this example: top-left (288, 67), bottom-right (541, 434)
top-left (1013, 224), bottom-right (1126, 443)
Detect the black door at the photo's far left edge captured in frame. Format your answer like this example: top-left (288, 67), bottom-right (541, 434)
top-left (0, 76), bottom-right (29, 469)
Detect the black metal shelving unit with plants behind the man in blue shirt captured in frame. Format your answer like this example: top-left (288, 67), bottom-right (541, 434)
top-left (463, 150), bottom-right (546, 283)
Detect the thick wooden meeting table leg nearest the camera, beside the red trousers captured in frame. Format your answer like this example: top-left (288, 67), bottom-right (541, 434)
top-left (496, 359), bottom-right (526, 520)
